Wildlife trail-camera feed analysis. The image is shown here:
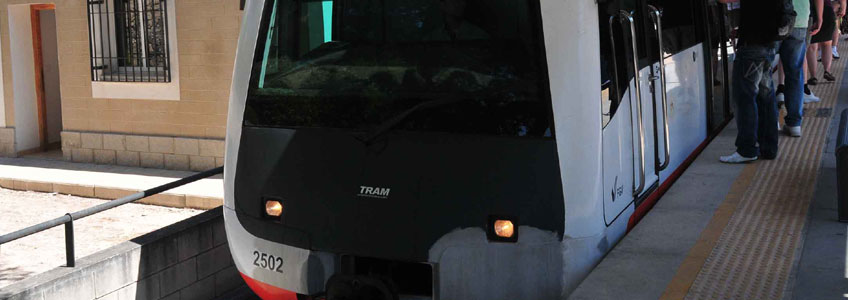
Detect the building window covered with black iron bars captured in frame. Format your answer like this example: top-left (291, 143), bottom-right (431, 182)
top-left (88, 0), bottom-right (171, 82)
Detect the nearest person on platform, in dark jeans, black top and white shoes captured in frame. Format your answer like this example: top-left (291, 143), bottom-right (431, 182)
top-left (719, 0), bottom-right (781, 163)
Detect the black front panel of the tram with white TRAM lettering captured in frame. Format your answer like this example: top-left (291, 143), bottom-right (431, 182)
top-left (235, 127), bottom-right (564, 261)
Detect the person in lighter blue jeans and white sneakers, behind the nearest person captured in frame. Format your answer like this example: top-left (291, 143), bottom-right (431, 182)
top-left (777, 0), bottom-right (830, 137)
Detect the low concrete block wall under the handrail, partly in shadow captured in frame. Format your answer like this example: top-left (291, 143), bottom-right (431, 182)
top-left (0, 208), bottom-right (244, 300)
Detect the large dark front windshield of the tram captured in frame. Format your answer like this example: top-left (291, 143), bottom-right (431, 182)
top-left (245, 0), bottom-right (552, 137)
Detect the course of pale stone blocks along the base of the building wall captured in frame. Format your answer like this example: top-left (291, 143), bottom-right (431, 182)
top-left (62, 131), bottom-right (224, 171)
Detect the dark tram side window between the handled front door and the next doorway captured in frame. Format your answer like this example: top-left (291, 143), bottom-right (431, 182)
top-left (648, 0), bottom-right (699, 55)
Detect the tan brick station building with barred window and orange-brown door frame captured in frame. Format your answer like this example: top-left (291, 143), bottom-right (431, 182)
top-left (0, 0), bottom-right (242, 171)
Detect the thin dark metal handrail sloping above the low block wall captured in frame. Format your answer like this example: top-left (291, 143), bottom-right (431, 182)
top-left (0, 167), bottom-right (224, 267)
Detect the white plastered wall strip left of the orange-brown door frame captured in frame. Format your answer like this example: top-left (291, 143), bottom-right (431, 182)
top-left (3, 5), bottom-right (40, 151)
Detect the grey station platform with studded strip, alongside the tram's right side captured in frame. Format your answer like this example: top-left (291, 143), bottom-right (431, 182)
top-left (570, 43), bottom-right (848, 299)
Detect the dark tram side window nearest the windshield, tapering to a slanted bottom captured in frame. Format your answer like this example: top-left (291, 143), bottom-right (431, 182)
top-left (598, 0), bottom-right (636, 127)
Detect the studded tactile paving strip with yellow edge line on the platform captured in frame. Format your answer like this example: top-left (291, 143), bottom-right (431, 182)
top-left (662, 43), bottom-right (848, 299)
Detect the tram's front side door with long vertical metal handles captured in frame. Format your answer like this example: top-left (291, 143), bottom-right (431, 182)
top-left (598, 0), bottom-right (666, 225)
